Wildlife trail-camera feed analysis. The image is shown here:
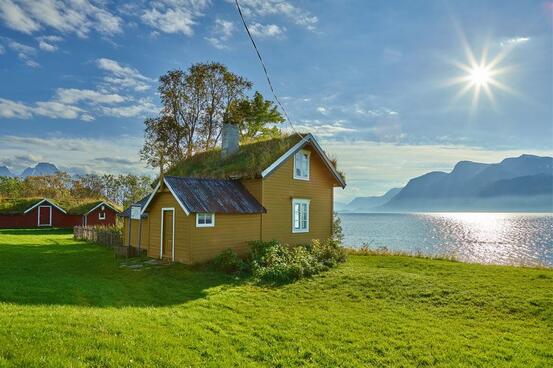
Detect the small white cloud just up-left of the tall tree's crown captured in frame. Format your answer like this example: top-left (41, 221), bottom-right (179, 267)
top-left (96, 58), bottom-right (153, 91)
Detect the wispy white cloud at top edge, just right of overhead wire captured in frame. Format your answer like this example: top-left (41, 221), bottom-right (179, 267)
top-left (235, 0), bottom-right (319, 31)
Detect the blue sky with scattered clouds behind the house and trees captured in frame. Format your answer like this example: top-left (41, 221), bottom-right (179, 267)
top-left (0, 0), bottom-right (553, 201)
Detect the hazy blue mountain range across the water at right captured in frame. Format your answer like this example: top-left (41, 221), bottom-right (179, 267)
top-left (342, 155), bottom-right (553, 212)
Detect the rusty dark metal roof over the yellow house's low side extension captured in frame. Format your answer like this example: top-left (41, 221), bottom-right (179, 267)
top-left (164, 176), bottom-right (266, 214)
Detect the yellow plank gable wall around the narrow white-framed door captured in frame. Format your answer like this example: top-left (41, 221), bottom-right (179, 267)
top-left (147, 188), bottom-right (194, 263)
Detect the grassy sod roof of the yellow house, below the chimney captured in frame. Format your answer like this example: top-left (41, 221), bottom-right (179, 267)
top-left (166, 134), bottom-right (301, 179)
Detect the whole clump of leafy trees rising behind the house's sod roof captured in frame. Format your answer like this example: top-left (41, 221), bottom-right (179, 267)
top-left (140, 62), bottom-right (284, 171)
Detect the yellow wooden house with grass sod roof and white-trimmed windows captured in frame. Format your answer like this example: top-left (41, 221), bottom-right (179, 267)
top-left (122, 130), bottom-right (346, 263)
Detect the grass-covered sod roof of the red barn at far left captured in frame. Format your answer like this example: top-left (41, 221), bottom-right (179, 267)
top-left (0, 197), bottom-right (121, 215)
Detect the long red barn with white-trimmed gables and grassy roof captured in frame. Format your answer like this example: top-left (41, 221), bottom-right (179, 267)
top-left (0, 198), bottom-right (119, 228)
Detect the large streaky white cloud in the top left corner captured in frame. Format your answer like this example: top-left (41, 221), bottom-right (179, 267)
top-left (0, 0), bottom-right (122, 37)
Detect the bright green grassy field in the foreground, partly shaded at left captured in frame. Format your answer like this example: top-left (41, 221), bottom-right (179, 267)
top-left (0, 230), bottom-right (553, 367)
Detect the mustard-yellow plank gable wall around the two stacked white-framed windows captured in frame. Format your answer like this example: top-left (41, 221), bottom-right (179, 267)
top-left (261, 147), bottom-right (335, 244)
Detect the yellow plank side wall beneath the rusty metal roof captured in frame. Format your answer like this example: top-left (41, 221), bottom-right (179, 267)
top-left (189, 213), bottom-right (261, 263)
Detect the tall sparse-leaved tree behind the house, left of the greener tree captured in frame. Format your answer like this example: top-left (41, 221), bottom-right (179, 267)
top-left (140, 63), bottom-right (252, 167)
